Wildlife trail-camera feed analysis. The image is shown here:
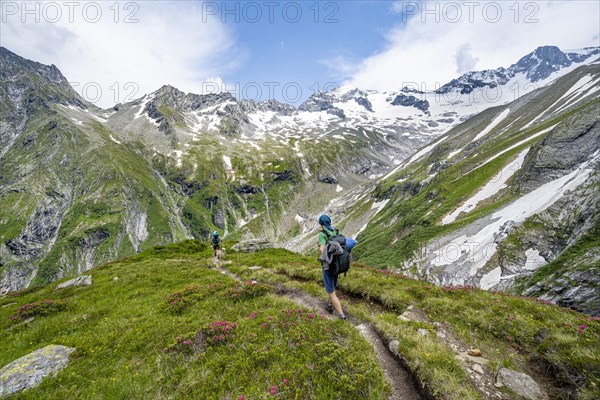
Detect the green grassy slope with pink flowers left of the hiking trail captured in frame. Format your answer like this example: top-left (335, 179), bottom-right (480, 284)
top-left (0, 241), bottom-right (389, 399)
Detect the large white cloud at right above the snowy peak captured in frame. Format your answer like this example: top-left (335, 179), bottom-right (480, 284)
top-left (338, 1), bottom-right (600, 91)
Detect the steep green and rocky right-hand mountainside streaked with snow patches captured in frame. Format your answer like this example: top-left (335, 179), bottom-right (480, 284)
top-left (328, 63), bottom-right (600, 315)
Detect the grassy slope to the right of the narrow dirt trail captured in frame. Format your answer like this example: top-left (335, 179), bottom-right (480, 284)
top-left (233, 250), bottom-right (600, 399)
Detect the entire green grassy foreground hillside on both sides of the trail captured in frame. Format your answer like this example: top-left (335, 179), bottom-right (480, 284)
top-left (0, 241), bottom-right (600, 399)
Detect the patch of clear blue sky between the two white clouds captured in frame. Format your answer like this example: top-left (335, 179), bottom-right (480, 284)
top-left (199, 1), bottom-right (401, 101)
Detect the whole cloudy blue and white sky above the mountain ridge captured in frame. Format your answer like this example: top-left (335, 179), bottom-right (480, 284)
top-left (0, 0), bottom-right (600, 108)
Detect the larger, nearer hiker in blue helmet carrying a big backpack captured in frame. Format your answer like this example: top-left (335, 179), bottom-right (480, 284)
top-left (317, 215), bottom-right (350, 319)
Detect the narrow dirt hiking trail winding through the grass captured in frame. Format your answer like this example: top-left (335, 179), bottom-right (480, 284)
top-left (215, 261), bottom-right (423, 400)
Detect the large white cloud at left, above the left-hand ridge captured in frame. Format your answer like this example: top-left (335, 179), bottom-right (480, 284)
top-left (0, 1), bottom-right (244, 107)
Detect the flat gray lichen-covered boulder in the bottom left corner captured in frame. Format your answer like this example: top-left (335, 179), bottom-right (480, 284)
top-left (0, 345), bottom-right (75, 397)
